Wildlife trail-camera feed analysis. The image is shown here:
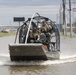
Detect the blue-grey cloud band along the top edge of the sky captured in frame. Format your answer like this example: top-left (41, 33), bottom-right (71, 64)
top-left (0, 0), bottom-right (60, 6)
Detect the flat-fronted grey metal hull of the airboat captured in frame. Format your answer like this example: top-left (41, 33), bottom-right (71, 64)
top-left (9, 44), bottom-right (59, 61)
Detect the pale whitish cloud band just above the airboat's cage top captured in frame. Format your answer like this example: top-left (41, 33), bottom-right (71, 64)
top-left (0, 5), bottom-right (59, 15)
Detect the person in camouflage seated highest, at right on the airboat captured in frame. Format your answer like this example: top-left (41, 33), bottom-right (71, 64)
top-left (41, 21), bottom-right (53, 51)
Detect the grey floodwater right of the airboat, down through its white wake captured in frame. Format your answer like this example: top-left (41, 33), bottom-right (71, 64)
top-left (60, 37), bottom-right (76, 59)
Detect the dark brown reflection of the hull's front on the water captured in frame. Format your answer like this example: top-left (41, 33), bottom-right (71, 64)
top-left (9, 66), bottom-right (46, 75)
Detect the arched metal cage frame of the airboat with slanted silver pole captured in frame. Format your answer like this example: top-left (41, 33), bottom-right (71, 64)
top-left (15, 13), bottom-right (60, 51)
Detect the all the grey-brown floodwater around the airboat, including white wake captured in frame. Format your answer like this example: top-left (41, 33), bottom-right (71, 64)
top-left (0, 36), bottom-right (76, 75)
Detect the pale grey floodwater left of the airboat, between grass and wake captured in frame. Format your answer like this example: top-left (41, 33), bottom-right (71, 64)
top-left (0, 36), bottom-right (15, 55)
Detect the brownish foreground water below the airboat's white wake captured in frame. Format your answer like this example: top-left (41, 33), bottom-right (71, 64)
top-left (0, 62), bottom-right (76, 75)
